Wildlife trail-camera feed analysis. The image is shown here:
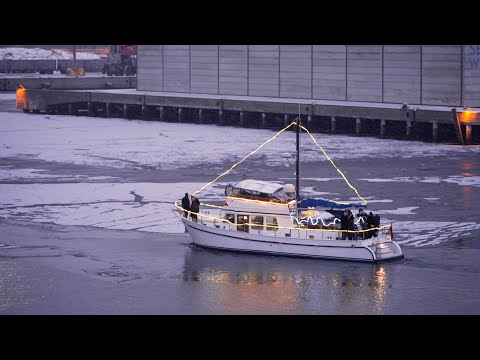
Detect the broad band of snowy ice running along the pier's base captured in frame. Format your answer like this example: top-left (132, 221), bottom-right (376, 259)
top-left (0, 113), bottom-right (480, 172)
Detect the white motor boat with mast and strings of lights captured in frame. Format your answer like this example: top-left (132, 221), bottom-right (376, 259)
top-left (175, 118), bottom-right (404, 262)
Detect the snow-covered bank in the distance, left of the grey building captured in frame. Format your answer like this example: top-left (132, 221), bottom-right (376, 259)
top-left (0, 48), bottom-right (100, 60)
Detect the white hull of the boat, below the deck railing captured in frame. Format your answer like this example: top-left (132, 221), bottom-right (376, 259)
top-left (182, 218), bottom-right (403, 262)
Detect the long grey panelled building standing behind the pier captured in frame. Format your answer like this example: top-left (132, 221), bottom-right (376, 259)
top-left (137, 45), bottom-right (480, 107)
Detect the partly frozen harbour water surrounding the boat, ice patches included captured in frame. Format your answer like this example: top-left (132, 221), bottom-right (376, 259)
top-left (0, 97), bottom-right (480, 314)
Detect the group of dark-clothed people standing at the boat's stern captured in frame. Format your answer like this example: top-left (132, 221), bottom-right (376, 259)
top-left (340, 208), bottom-right (380, 240)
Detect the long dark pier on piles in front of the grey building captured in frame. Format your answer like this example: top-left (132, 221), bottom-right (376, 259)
top-left (17, 88), bottom-right (480, 145)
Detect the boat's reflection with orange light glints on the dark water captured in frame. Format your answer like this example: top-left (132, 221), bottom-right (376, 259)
top-left (183, 246), bottom-right (395, 314)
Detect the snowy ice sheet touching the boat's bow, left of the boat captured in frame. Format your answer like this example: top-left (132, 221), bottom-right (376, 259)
top-left (0, 183), bottom-right (225, 233)
